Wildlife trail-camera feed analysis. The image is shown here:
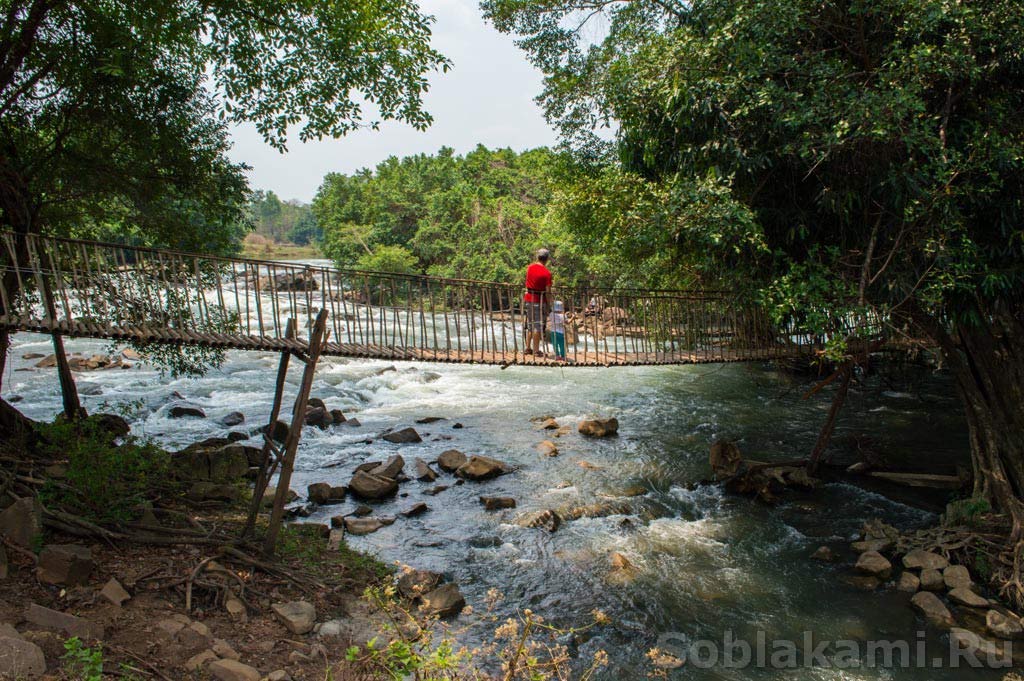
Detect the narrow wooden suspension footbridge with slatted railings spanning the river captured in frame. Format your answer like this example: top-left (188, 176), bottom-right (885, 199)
top-left (0, 231), bottom-right (883, 367)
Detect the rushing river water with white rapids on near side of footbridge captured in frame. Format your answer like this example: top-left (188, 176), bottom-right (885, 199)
top-left (3, 327), bottom-right (997, 679)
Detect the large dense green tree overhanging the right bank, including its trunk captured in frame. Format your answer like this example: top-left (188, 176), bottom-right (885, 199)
top-left (483, 0), bottom-right (1024, 539)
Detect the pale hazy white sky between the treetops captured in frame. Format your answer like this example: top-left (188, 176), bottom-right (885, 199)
top-left (231, 0), bottom-right (555, 201)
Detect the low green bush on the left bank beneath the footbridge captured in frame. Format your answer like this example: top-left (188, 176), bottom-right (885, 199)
top-left (38, 419), bottom-right (172, 522)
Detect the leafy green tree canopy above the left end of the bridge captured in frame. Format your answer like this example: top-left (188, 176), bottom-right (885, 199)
top-left (0, 0), bottom-right (447, 251)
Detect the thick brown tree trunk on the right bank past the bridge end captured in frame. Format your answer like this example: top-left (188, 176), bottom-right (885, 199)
top-left (928, 305), bottom-right (1024, 541)
